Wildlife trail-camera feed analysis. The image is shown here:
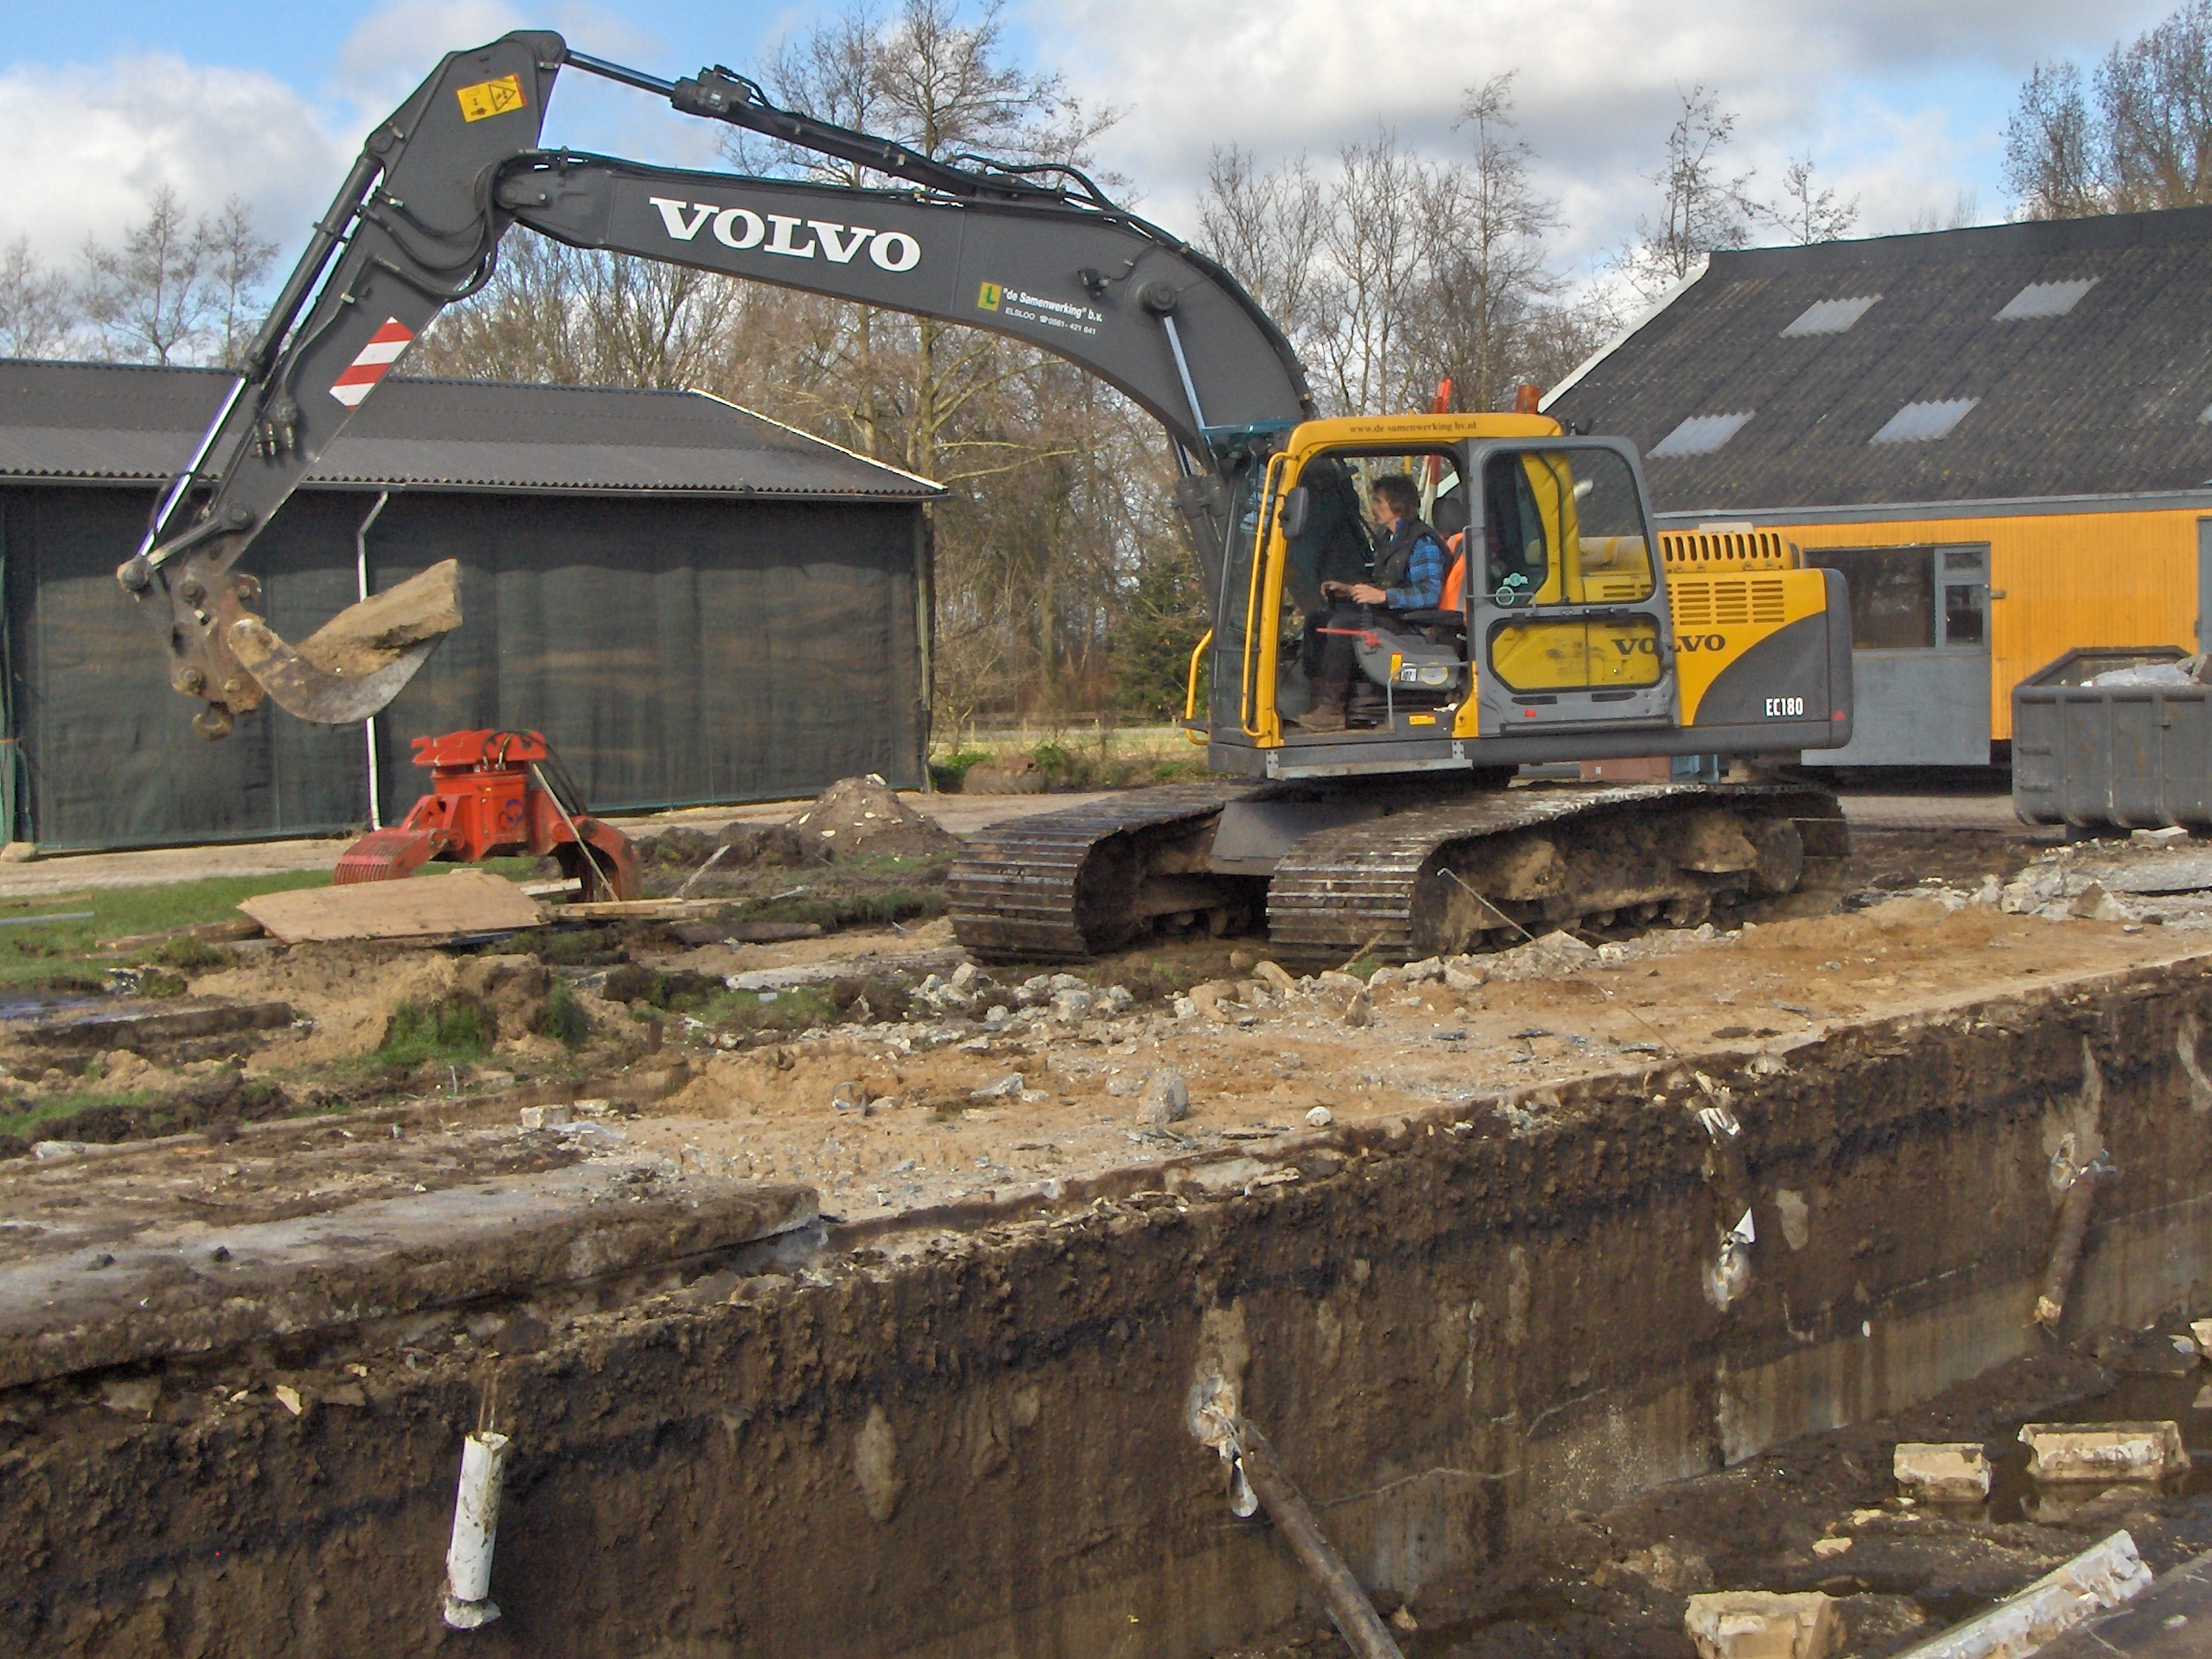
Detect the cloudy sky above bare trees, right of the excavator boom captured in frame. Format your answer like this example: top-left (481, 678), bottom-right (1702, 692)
top-left (1024, 0), bottom-right (2173, 259)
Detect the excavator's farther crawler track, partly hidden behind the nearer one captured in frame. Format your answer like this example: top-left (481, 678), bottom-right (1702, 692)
top-left (947, 779), bottom-right (1257, 962)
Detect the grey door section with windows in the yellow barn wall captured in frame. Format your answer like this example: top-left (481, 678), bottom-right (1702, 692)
top-left (1805, 544), bottom-right (1988, 765)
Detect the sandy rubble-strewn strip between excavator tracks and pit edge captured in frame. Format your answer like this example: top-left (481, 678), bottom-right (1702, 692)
top-left (597, 901), bottom-right (2212, 1219)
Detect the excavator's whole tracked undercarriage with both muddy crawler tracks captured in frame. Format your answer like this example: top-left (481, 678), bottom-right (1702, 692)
top-left (951, 777), bottom-right (1849, 967)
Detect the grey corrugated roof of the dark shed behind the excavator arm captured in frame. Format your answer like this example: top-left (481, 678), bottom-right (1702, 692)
top-left (0, 358), bottom-right (938, 500)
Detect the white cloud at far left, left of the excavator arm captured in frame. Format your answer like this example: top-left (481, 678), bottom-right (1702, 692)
top-left (0, 53), bottom-right (351, 265)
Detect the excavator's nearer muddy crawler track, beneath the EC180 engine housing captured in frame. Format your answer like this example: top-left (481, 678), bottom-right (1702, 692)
top-left (1267, 783), bottom-right (1849, 962)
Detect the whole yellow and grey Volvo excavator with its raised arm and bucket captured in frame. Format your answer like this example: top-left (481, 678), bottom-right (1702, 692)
top-left (117, 31), bottom-right (1851, 960)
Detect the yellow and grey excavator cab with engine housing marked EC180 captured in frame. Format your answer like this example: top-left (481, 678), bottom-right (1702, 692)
top-left (1192, 414), bottom-right (1849, 779)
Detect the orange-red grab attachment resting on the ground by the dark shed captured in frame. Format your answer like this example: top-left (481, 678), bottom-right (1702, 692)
top-left (332, 733), bottom-right (637, 898)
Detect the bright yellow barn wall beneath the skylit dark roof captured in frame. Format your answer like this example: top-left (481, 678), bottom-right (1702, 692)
top-left (1761, 511), bottom-right (2199, 741)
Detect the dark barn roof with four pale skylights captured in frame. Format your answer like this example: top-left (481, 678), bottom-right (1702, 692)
top-left (1544, 208), bottom-right (2212, 514)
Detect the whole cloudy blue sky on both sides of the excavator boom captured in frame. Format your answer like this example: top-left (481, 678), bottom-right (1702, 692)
top-left (0, 0), bottom-right (2173, 289)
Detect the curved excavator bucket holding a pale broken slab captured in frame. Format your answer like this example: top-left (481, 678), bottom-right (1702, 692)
top-left (230, 560), bottom-right (460, 726)
